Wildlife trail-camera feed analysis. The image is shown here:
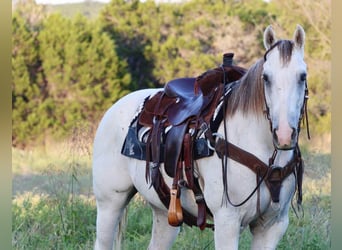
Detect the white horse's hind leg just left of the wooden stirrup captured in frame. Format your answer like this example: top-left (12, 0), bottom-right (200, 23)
top-left (148, 206), bottom-right (179, 250)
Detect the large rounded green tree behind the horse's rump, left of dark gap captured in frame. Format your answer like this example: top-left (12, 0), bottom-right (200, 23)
top-left (39, 14), bottom-right (130, 136)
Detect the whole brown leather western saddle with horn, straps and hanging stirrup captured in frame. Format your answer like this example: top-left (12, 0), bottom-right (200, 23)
top-left (138, 53), bottom-right (246, 230)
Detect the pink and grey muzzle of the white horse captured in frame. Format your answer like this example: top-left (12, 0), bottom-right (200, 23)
top-left (273, 127), bottom-right (298, 150)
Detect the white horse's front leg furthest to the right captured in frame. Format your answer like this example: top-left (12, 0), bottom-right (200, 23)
top-left (251, 213), bottom-right (289, 250)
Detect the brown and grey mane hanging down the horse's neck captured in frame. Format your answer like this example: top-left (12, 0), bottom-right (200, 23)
top-left (227, 59), bottom-right (265, 115)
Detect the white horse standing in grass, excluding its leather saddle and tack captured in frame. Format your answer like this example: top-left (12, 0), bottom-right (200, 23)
top-left (93, 25), bottom-right (307, 250)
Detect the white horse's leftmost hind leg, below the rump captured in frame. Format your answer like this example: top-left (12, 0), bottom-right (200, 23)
top-left (95, 187), bottom-right (137, 250)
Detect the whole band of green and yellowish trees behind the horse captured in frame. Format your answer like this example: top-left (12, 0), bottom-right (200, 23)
top-left (12, 0), bottom-right (331, 146)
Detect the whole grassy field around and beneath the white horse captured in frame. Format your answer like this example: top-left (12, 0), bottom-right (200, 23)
top-left (12, 143), bottom-right (331, 250)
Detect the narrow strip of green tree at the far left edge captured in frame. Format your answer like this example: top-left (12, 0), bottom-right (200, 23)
top-left (12, 13), bottom-right (45, 145)
